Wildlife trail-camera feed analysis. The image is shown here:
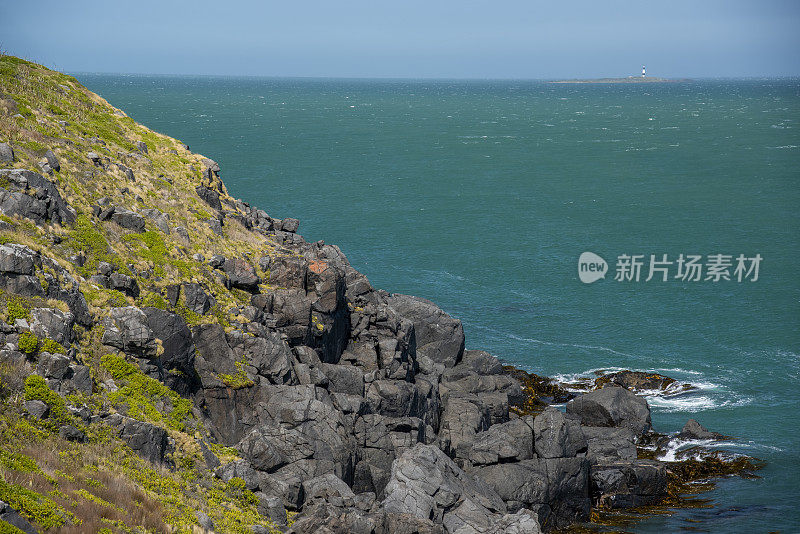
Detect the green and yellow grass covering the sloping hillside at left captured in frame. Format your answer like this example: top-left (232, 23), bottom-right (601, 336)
top-left (0, 55), bottom-right (288, 533)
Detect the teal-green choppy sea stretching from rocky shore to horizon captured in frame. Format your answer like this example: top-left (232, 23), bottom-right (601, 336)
top-left (77, 74), bottom-right (800, 533)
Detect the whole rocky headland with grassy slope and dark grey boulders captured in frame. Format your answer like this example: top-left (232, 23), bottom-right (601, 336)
top-left (0, 56), bottom-right (760, 534)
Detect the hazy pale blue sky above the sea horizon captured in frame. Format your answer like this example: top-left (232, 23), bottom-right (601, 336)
top-left (0, 0), bottom-right (800, 78)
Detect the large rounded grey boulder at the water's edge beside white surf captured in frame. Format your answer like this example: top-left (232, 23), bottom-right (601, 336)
top-left (567, 386), bottom-right (650, 435)
